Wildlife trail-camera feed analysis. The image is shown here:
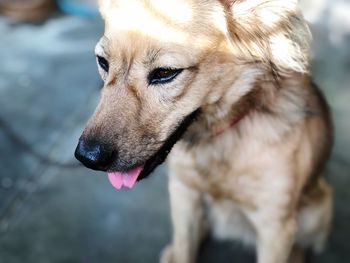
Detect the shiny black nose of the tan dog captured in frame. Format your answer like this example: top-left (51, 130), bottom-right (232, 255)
top-left (74, 139), bottom-right (114, 171)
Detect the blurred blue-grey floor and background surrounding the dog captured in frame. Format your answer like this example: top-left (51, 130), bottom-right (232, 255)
top-left (0, 0), bottom-right (350, 263)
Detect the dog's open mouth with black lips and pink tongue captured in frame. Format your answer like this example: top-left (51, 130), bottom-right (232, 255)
top-left (107, 109), bottom-right (200, 190)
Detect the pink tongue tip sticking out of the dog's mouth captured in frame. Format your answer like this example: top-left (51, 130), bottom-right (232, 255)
top-left (107, 166), bottom-right (143, 190)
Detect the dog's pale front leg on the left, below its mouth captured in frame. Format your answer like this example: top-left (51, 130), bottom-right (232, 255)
top-left (160, 176), bottom-right (203, 263)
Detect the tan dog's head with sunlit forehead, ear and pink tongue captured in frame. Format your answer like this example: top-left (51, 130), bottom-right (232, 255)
top-left (76, 0), bottom-right (307, 188)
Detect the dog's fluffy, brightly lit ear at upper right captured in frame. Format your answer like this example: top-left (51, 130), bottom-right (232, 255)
top-left (219, 0), bottom-right (310, 73)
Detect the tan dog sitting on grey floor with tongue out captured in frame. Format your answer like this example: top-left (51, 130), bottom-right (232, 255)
top-left (75, 0), bottom-right (333, 263)
